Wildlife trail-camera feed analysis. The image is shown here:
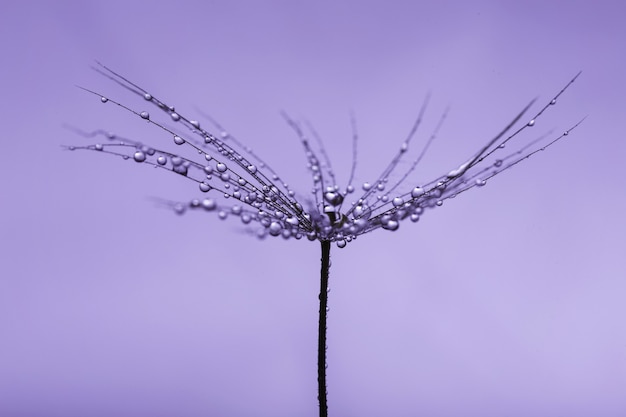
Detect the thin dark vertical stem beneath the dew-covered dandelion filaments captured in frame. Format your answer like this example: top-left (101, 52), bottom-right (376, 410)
top-left (317, 240), bottom-right (330, 417)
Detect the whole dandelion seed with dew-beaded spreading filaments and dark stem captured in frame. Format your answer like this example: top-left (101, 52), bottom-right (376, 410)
top-left (68, 63), bottom-right (582, 416)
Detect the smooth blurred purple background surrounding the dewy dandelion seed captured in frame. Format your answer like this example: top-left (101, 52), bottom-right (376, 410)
top-left (0, 1), bottom-right (626, 417)
